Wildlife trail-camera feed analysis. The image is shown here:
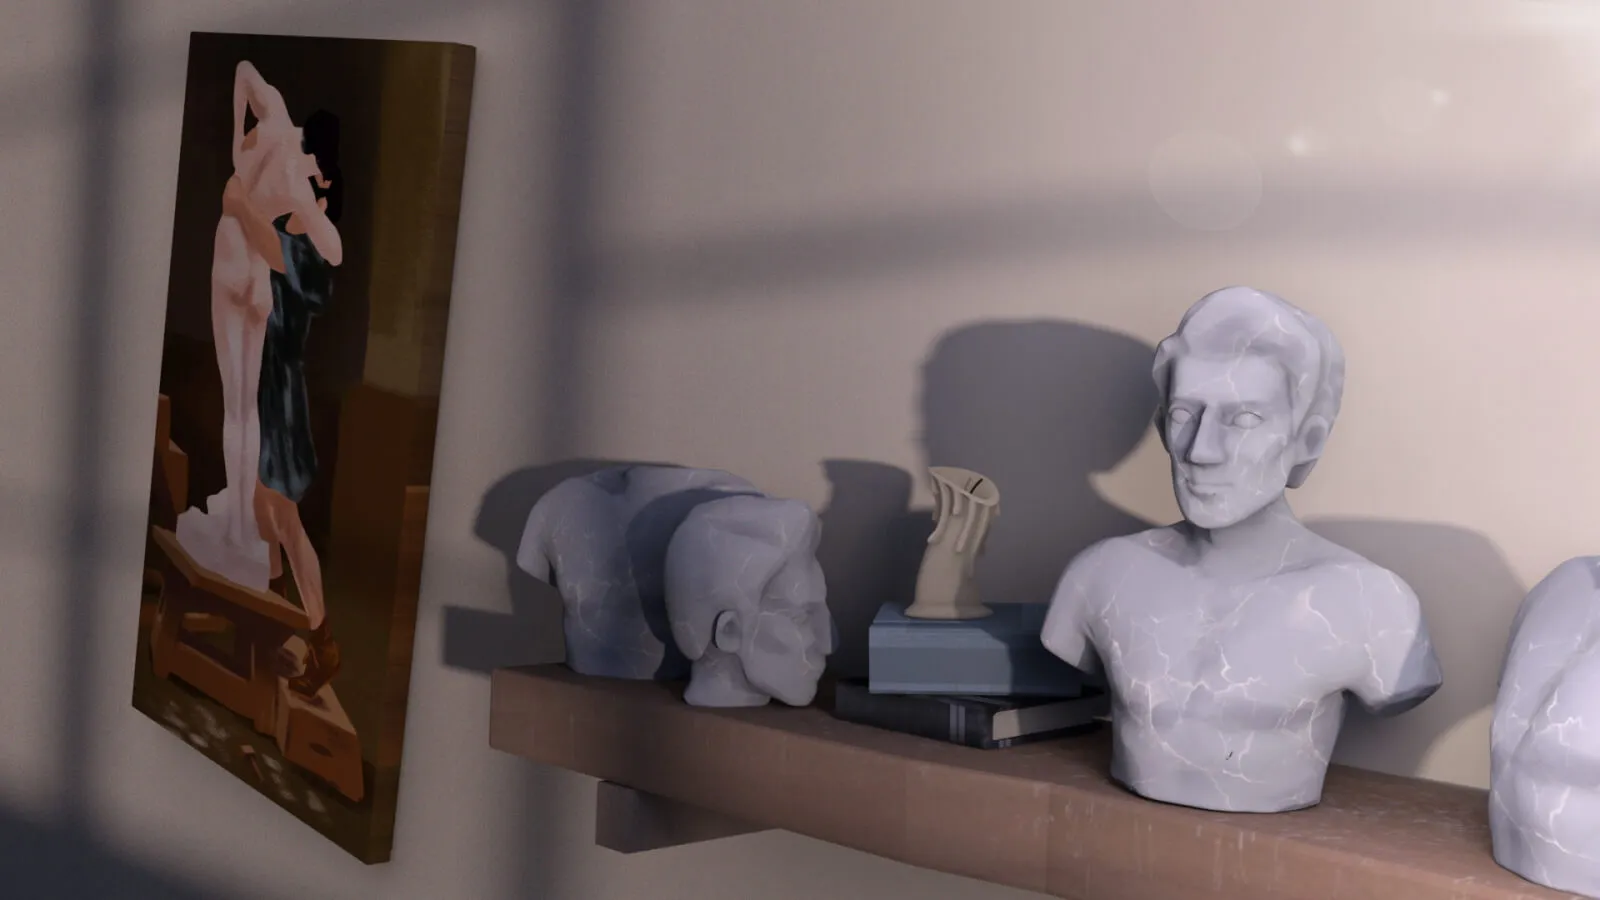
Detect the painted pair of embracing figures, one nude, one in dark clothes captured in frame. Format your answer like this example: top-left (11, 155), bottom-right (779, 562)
top-left (178, 61), bottom-right (342, 679)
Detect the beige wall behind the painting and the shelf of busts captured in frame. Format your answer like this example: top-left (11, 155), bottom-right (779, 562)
top-left (0, 0), bottom-right (1600, 900)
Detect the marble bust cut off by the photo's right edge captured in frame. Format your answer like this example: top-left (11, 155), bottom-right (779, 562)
top-left (1490, 557), bottom-right (1600, 897)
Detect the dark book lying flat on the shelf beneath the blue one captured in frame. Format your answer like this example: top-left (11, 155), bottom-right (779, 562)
top-left (832, 679), bottom-right (1110, 749)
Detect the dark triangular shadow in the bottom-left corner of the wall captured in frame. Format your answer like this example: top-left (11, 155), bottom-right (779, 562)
top-left (0, 809), bottom-right (221, 900)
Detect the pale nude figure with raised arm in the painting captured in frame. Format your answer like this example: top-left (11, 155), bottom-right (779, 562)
top-left (178, 61), bottom-right (344, 602)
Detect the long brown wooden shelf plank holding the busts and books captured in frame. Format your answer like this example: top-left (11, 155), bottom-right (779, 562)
top-left (490, 666), bottom-right (1571, 900)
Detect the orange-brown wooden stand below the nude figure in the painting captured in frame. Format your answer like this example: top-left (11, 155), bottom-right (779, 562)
top-left (146, 396), bottom-right (365, 802)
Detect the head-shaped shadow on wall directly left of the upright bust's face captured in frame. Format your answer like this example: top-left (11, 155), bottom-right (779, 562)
top-left (922, 322), bottom-right (1157, 602)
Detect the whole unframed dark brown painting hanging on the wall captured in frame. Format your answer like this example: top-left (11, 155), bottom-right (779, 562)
top-left (133, 34), bottom-right (474, 863)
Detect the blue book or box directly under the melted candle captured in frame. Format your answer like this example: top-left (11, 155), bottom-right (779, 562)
top-left (867, 604), bottom-right (1083, 697)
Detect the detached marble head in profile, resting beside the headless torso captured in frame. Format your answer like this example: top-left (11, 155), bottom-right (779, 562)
top-left (666, 496), bottom-right (838, 706)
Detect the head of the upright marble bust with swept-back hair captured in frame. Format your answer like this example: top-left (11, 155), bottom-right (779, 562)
top-left (1152, 287), bottom-right (1344, 528)
